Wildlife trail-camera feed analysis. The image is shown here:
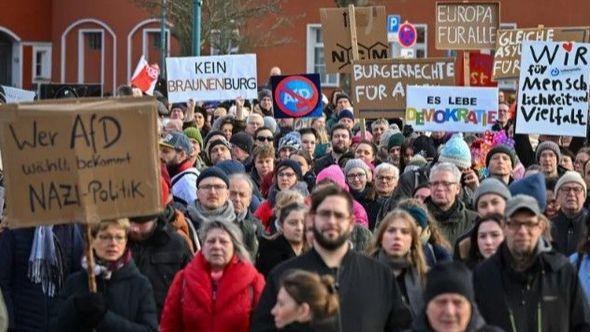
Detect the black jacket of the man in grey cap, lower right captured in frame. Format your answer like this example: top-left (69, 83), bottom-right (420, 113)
top-left (473, 240), bottom-right (590, 332)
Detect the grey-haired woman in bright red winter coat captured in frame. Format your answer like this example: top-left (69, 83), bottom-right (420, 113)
top-left (160, 221), bottom-right (264, 332)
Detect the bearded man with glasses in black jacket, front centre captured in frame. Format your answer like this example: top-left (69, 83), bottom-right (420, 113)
top-left (251, 185), bottom-right (411, 332)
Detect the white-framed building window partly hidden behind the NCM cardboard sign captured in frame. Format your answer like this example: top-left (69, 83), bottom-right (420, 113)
top-left (307, 24), bottom-right (340, 87)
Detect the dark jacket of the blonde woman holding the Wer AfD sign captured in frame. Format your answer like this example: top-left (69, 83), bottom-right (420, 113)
top-left (52, 260), bottom-right (158, 332)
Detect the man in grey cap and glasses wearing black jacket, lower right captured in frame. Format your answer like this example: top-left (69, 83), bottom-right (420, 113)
top-left (473, 195), bottom-right (590, 331)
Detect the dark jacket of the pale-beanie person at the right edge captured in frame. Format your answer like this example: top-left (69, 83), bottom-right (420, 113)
top-left (551, 209), bottom-right (588, 256)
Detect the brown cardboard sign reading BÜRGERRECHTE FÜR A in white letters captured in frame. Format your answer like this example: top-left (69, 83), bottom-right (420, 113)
top-left (351, 58), bottom-right (455, 119)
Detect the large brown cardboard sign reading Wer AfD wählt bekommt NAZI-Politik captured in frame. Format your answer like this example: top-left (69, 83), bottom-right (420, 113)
top-left (0, 98), bottom-right (161, 227)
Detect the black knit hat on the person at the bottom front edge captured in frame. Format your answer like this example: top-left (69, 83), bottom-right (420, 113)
top-left (424, 261), bottom-right (475, 305)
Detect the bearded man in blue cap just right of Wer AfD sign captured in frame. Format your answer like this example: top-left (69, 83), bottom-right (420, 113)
top-left (160, 132), bottom-right (199, 206)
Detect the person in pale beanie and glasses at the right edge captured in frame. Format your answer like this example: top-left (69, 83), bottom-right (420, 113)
top-left (551, 171), bottom-right (588, 256)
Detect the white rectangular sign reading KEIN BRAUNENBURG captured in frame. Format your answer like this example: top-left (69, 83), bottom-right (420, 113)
top-left (166, 54), bottom-right (258, 103)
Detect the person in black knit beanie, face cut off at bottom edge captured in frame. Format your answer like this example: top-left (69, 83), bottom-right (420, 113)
top-left (412, 262), bottom-right (490, 332)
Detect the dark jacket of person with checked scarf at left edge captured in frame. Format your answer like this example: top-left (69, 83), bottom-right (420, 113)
top-left (0, 225), bottom-right (84, 331)
